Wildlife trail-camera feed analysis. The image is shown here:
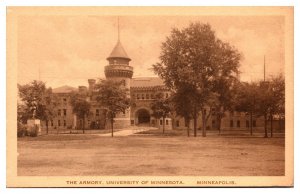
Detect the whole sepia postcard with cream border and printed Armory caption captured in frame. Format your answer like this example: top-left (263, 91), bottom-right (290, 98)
top-left (7, 7), bottom-right (294, 187)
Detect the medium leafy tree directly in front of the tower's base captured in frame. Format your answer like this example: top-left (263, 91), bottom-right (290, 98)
top-left (95, 80), bottom-right (130, 137)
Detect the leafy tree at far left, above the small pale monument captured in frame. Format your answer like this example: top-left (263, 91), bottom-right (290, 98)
top-left (18, 80), bottom-right (57, 134)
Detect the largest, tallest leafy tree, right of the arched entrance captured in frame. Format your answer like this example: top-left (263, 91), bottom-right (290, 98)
top-left (153, 23), bottom-right (241, 136)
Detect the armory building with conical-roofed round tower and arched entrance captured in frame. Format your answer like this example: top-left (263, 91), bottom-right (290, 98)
top-left (49, 37), bottom-right (284, 133)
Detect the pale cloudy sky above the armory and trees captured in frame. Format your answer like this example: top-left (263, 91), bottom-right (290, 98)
top-left (17, 15), bottom-right (284, 88)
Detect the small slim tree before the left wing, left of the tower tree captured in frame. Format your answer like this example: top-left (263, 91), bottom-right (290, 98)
top-left (70, 93), bottom-right (91, 133)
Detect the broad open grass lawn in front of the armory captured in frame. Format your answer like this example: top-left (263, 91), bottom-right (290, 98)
top-left (18, 134), bottom-right (284, 176)
